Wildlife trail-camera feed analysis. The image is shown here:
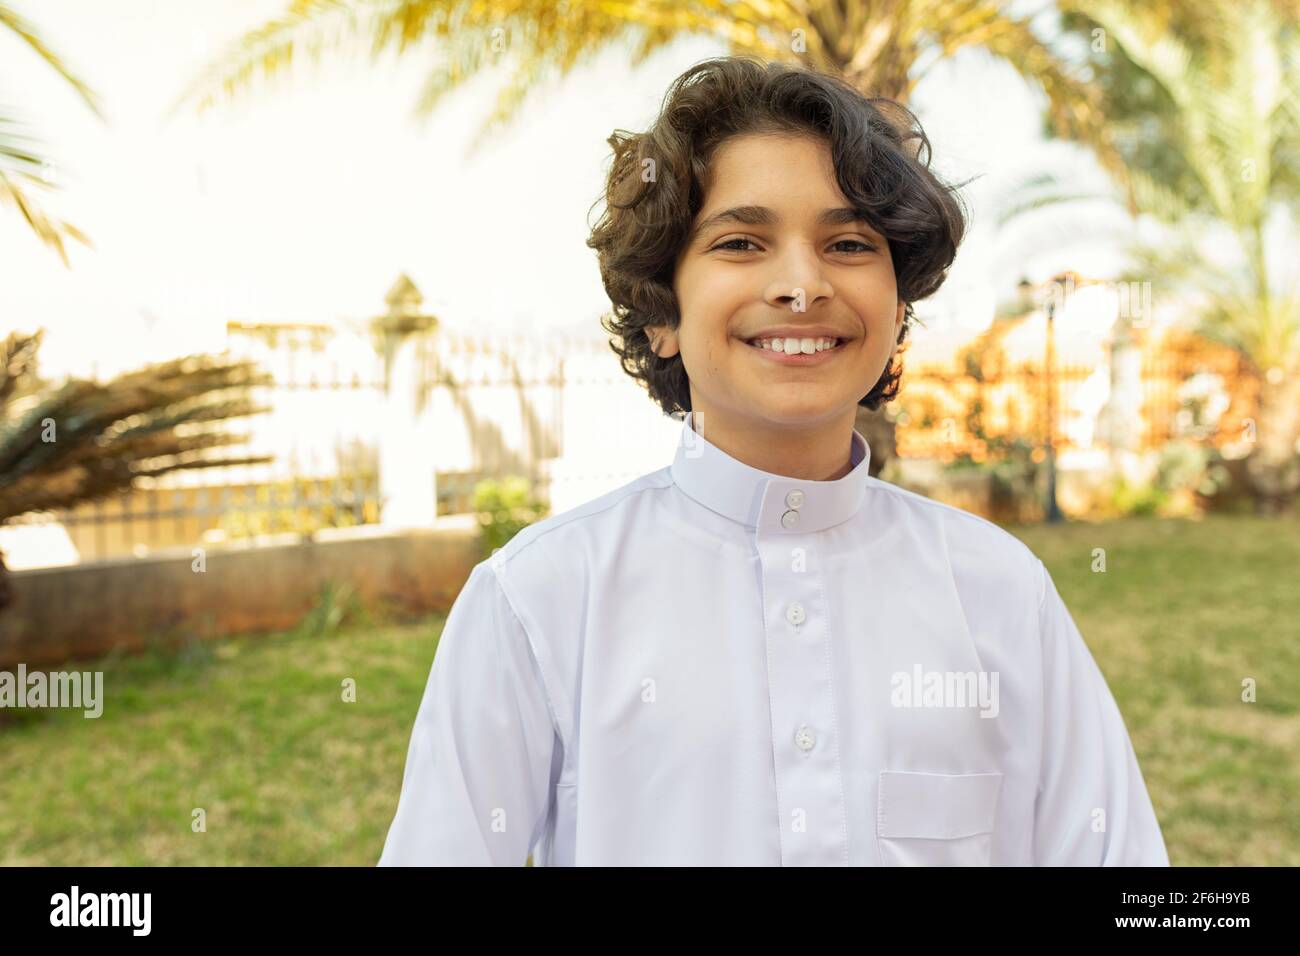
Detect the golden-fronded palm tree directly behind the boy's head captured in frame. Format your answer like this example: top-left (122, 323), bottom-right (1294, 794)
top-left (173, 0), bottom-right (1149, 475)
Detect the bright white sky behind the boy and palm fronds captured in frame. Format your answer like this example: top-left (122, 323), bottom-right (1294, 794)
top-left (0, 0), bottom-right (1133, 382)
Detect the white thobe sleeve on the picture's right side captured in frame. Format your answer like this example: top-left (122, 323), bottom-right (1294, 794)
top-left (1034, 561), bottom-right (1169, 866)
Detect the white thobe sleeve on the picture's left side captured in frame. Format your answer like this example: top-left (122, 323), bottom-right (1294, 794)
top-left (378, 562), bottom-right (563, 866)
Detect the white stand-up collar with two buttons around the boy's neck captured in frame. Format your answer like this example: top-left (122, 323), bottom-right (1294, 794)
top-left (671, 411), bottom-right (871, 535)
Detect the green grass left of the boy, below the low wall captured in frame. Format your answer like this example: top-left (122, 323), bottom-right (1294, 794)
top-left (0, 620), bottom-right (441, 866)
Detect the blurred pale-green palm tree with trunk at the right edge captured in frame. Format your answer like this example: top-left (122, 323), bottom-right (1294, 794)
top-left (1063, 0), bottom-right (1300, 511)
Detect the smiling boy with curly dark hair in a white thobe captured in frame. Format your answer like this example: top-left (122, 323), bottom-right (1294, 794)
top-left (380, 57), bottom-right (1169, 866)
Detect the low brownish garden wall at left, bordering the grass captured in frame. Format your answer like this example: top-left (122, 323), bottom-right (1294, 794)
top-left (0, 515), bottom-right (481, 669)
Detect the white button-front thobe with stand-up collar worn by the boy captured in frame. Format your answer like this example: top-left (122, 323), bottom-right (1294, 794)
top-left (380, 415), bottom-right (1169, 866)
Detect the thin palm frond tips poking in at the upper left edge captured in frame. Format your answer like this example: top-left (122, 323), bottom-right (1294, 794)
top-left (0, 4), bottom-right (104, 265)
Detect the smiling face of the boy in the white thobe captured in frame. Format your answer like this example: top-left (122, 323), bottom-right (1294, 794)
top-left (649, 134), bottom-right (905, 433)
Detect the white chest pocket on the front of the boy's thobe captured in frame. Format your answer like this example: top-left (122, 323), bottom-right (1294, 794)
top-left (876, 770), bottom-right (1002, 866)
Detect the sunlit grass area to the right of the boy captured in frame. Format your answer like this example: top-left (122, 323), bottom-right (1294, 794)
top-left (1010, 516), bottom-right (1300, 866)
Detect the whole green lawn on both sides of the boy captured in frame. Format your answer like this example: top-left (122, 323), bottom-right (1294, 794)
top-left (0, 516), bottom-right (1300, 866)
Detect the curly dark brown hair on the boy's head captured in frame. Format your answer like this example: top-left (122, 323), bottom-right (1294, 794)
top-left (586, 56), bottom-right (969, 416)
